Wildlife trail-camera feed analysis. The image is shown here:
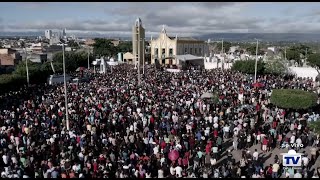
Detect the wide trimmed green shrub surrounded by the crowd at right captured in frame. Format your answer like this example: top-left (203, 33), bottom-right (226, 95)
top-left (271, 89), bottom-right (317, 110)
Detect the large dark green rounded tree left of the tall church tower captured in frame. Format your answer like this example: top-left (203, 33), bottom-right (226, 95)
top-left (93, 38), bottom-right (117, 57)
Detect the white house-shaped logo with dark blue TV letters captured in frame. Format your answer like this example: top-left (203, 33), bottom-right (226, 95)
top-left (281, 149), bottom-right (303, 167)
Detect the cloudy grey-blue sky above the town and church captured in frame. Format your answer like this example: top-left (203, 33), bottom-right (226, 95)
top-left (0, 2), bottom-right (320, 36)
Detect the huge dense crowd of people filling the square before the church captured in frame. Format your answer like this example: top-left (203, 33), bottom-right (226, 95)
top-left (0, 65), bottom-right (320, 178)
